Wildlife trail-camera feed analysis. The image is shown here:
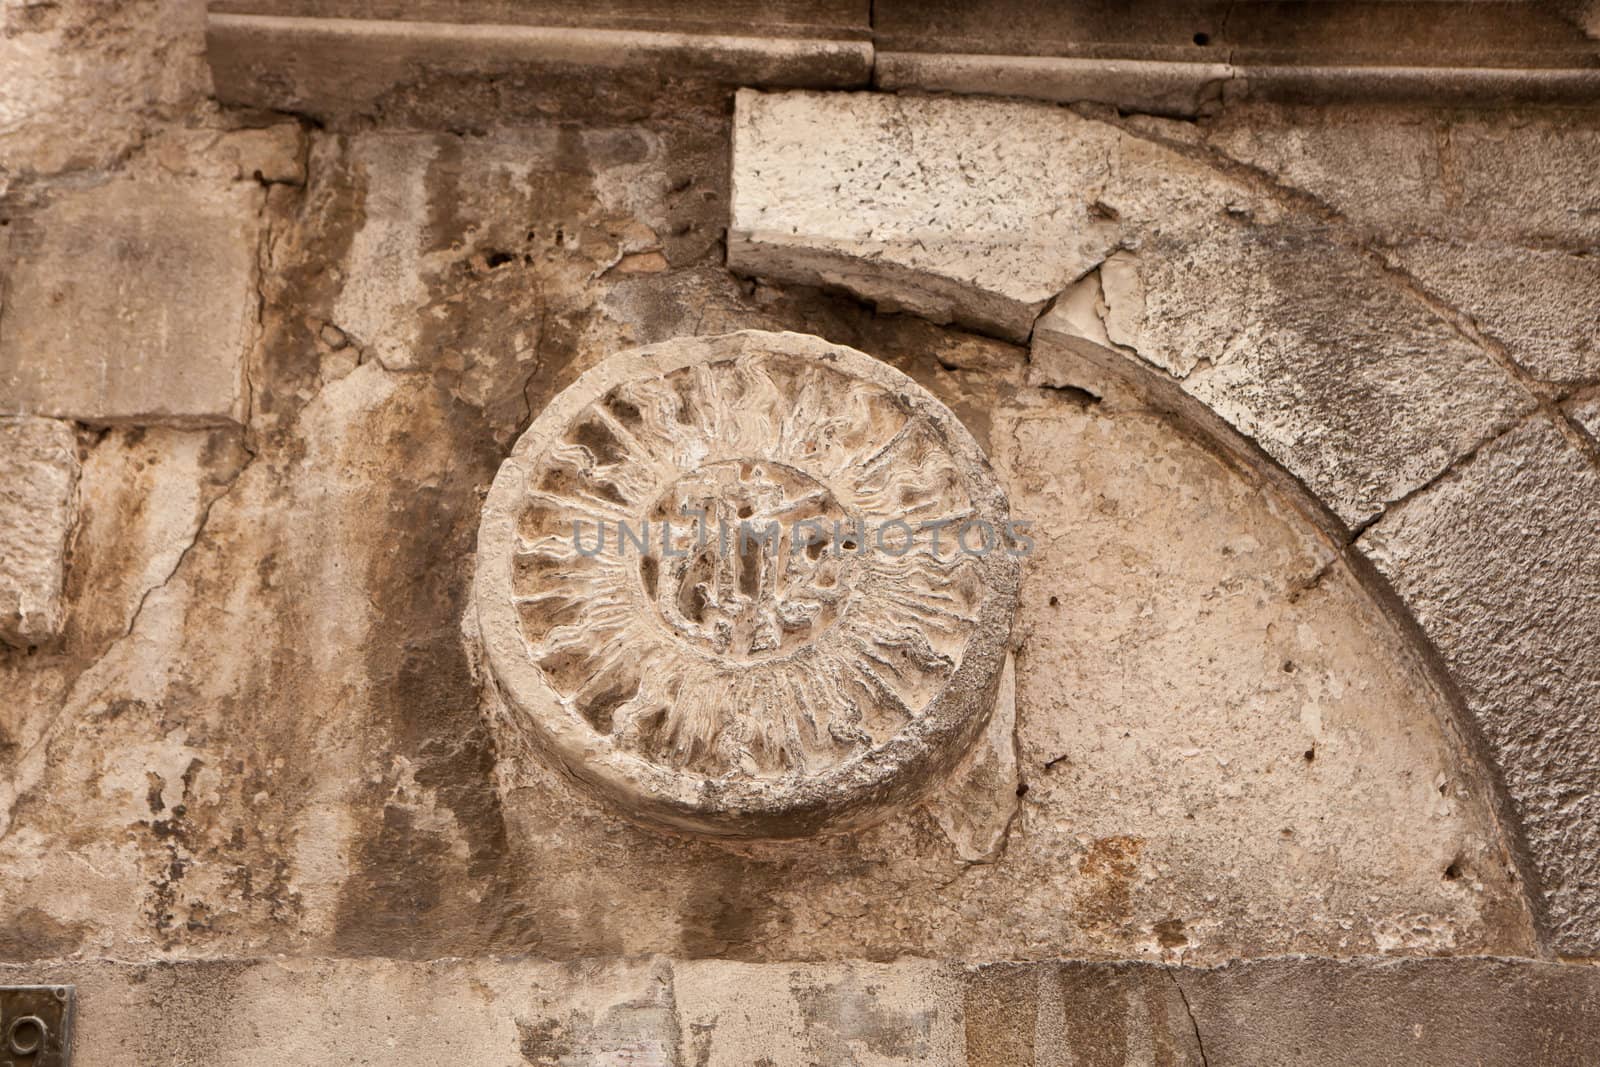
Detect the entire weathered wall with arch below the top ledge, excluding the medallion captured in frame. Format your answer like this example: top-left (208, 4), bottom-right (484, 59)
top-left (0, 6), bottom-right (1600, 1064)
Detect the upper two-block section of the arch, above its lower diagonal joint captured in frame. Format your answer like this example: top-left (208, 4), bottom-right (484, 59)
top-left (728, 93), bottom-right (1536, 528)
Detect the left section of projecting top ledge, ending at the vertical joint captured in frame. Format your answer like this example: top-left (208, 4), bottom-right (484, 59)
top-left (206, 13), bottom-right (872, 115)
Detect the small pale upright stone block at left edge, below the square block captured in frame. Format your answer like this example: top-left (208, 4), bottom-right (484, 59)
top-left (0, 418), bottom-right (78, 646)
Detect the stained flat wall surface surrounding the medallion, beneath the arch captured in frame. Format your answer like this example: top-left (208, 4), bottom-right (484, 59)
top-left (0, 117), bottom-right (1534, 961)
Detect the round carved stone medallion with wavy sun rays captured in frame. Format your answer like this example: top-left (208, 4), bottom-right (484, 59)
top-left (475, 331), bottom-right (1027, 837)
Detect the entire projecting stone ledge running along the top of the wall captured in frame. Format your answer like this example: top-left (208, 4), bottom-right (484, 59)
top-left (208, 11), bottom-right (1600, 117)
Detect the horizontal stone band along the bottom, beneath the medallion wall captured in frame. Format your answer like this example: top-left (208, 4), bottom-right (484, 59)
top-left (0, 957), bottom-right (1600, 1067)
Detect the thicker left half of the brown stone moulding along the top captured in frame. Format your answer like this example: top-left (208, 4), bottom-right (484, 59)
top-left (206, 5), bottom-right (872, 125)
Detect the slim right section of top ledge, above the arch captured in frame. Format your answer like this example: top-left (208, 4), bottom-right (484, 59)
top-left (874, 51), bottom-right (1600, 117)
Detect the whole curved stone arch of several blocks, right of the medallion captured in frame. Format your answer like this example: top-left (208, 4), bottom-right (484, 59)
top-left (728, 85), bottom-right (1600, 955)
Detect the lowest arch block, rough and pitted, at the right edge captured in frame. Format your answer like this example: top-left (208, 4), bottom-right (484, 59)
top-left (1360, 419), bottom-right (1600, 955)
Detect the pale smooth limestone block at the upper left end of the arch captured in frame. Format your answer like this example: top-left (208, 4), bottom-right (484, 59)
top-left (728, 91), bottom-right (1117, 339)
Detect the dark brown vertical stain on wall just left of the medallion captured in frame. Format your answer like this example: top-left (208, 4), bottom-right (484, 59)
top-left (334, 378), bottom-right (507, 955)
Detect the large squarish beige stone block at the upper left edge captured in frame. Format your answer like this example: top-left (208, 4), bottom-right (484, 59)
top-left (0, 181), bottom-right (261, 424)
